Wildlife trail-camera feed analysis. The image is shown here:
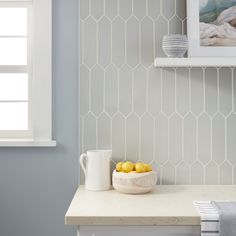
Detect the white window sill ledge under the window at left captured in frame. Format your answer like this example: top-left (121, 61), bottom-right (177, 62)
top-left (0, 139), bottom-right (57, 147)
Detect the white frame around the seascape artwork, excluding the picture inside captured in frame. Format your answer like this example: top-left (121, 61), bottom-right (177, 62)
top-left (187, 0), bottom-right (236, 57)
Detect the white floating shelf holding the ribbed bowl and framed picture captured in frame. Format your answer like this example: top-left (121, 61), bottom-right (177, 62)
top-left (154, 57), bottom-right (236, 67)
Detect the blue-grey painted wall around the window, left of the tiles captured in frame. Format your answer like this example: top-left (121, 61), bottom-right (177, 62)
top-left (0, 0), bottom-right (78, 236)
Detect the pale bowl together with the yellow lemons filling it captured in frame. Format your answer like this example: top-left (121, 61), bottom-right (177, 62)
top-left (112, 161), bottom-right (157, 194)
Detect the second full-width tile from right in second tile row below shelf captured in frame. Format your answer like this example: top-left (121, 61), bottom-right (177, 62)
top-left (198, 114), bottom-right (211, 164)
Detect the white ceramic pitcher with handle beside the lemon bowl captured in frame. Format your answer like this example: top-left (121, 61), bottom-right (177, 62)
top-left (80, 150), bottom-right (112, 191)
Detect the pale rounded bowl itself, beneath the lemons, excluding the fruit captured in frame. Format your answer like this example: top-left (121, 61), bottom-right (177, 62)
top-left (112, 170), bottom-right (157, 194)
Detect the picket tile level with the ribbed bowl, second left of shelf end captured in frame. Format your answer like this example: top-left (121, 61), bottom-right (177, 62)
top-left (126, 17), bottom-right (140, 67)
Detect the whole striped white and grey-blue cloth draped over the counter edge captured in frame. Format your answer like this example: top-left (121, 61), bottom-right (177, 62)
top-left (194, 201), bottom-right (236, 236)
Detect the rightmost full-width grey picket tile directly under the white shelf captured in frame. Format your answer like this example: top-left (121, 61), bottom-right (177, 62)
top-left (219, 68), bottom-right (232, 115)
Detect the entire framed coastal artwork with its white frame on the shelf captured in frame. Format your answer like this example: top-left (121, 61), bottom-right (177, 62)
top-left (187, 0), bottom-right (236, 57)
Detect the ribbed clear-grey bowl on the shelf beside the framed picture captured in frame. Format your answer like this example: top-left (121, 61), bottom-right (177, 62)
top-left (162, 34), bottom-right (188, 57)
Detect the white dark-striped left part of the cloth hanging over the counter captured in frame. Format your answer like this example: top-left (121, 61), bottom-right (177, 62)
top-left (194, 201), bottom-right (220, 236)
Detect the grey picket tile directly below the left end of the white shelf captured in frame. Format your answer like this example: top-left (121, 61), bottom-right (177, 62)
top-left (147, 67), bottom-right (161, 116)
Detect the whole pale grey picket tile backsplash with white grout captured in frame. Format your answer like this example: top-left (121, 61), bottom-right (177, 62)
top-left (79, 0), bottom-right (236, 184)
